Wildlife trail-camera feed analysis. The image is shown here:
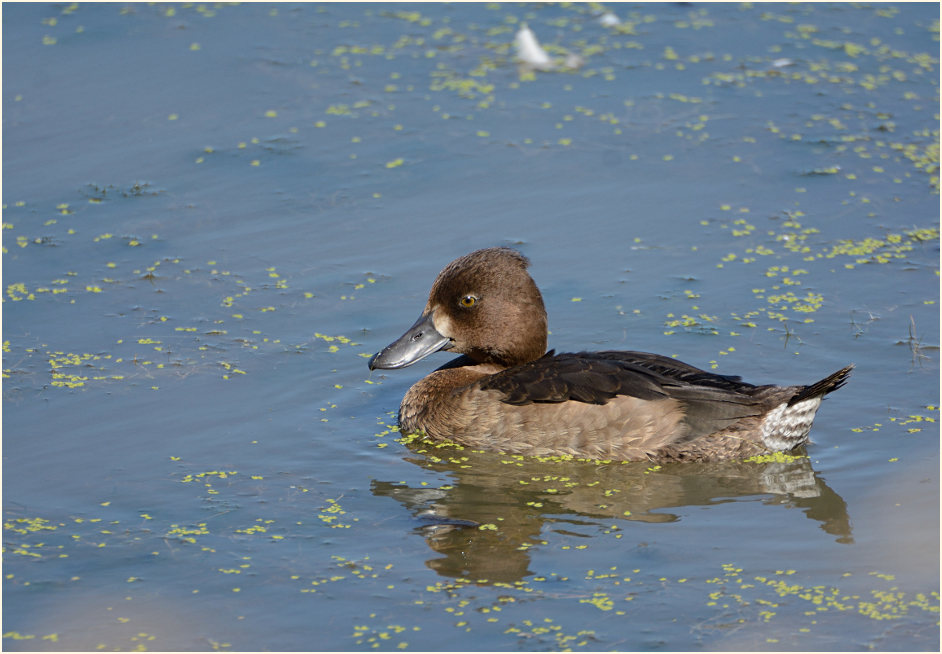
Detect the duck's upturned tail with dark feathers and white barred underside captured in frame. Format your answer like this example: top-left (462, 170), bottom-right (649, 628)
top-left (760, 364), bottom-right (854, 451)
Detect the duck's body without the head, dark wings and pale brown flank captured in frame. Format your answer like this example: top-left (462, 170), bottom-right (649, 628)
top-left (401, 351), bottom-right (850, 460)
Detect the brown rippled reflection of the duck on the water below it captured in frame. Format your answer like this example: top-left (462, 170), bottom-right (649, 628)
top-left (372, 445), bottom-right (853, 583)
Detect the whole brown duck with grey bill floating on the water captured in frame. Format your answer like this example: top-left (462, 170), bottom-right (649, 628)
top-left (369, 247), bottom-right (854, 463)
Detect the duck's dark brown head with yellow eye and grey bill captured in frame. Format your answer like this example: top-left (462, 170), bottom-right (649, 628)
top-left (370, 248), bottom-right (546, 370)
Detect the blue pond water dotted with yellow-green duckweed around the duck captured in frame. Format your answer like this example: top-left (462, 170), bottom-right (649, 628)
top-left (2, 3), bottom-right (939, 650)
